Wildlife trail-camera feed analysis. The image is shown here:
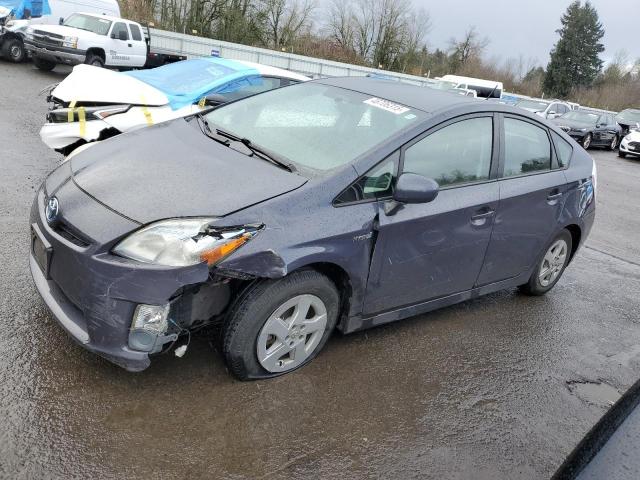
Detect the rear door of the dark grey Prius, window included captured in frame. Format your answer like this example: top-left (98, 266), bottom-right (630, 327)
top-left (478, 115), bottom-right (567, 285)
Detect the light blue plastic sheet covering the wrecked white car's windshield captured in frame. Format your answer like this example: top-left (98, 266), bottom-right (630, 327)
top-left (124, 57), bottom-right (262, 110)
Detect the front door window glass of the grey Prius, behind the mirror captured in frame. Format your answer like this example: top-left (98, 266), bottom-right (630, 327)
top-left (403, 117), bottom-right (493, 186)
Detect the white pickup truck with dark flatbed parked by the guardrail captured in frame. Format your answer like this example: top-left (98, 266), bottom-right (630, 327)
top-left (24, 13), bottom-right (186, 70)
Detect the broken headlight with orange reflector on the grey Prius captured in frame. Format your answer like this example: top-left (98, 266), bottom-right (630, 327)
top-left (113, 218), bottom-right (262, 267)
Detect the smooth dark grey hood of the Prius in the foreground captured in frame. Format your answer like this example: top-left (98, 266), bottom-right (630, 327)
top-left (71, 119), bottom-right (307, 224)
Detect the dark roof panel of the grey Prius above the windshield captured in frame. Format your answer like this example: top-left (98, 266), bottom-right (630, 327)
top-left (315, 77), bottom-right (478, 113)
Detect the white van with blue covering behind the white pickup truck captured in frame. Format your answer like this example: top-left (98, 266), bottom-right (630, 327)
top-left (0, 0), bottom-right (120, 63)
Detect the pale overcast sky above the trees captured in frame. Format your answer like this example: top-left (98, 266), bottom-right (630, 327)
top-left (412, 0), bottom-right (640, 66)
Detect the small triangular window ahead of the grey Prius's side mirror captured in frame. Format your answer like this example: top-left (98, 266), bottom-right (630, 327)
top-left (334, 151), bottom-right (400, 205)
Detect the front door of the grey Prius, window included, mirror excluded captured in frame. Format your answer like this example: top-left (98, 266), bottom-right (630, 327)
top-left (364, 115), bottom-right (498, 314)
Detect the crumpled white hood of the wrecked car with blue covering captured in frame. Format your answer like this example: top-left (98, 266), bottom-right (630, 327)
top-left (51, 65), bottom-right (169, 106)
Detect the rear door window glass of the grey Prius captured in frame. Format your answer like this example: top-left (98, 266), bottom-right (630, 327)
top-left (504, 118), bottom-right (551, 177)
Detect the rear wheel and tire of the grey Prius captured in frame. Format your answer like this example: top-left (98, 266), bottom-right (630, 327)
top-left (519, 229), bottom-right (573, 295)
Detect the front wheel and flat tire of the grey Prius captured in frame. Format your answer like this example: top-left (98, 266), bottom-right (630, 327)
top-left (222, 270), bottom-right (340, 380)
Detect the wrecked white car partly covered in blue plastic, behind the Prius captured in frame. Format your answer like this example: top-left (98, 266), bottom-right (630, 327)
top-left (40, 57), bottom-right (309, 155)
